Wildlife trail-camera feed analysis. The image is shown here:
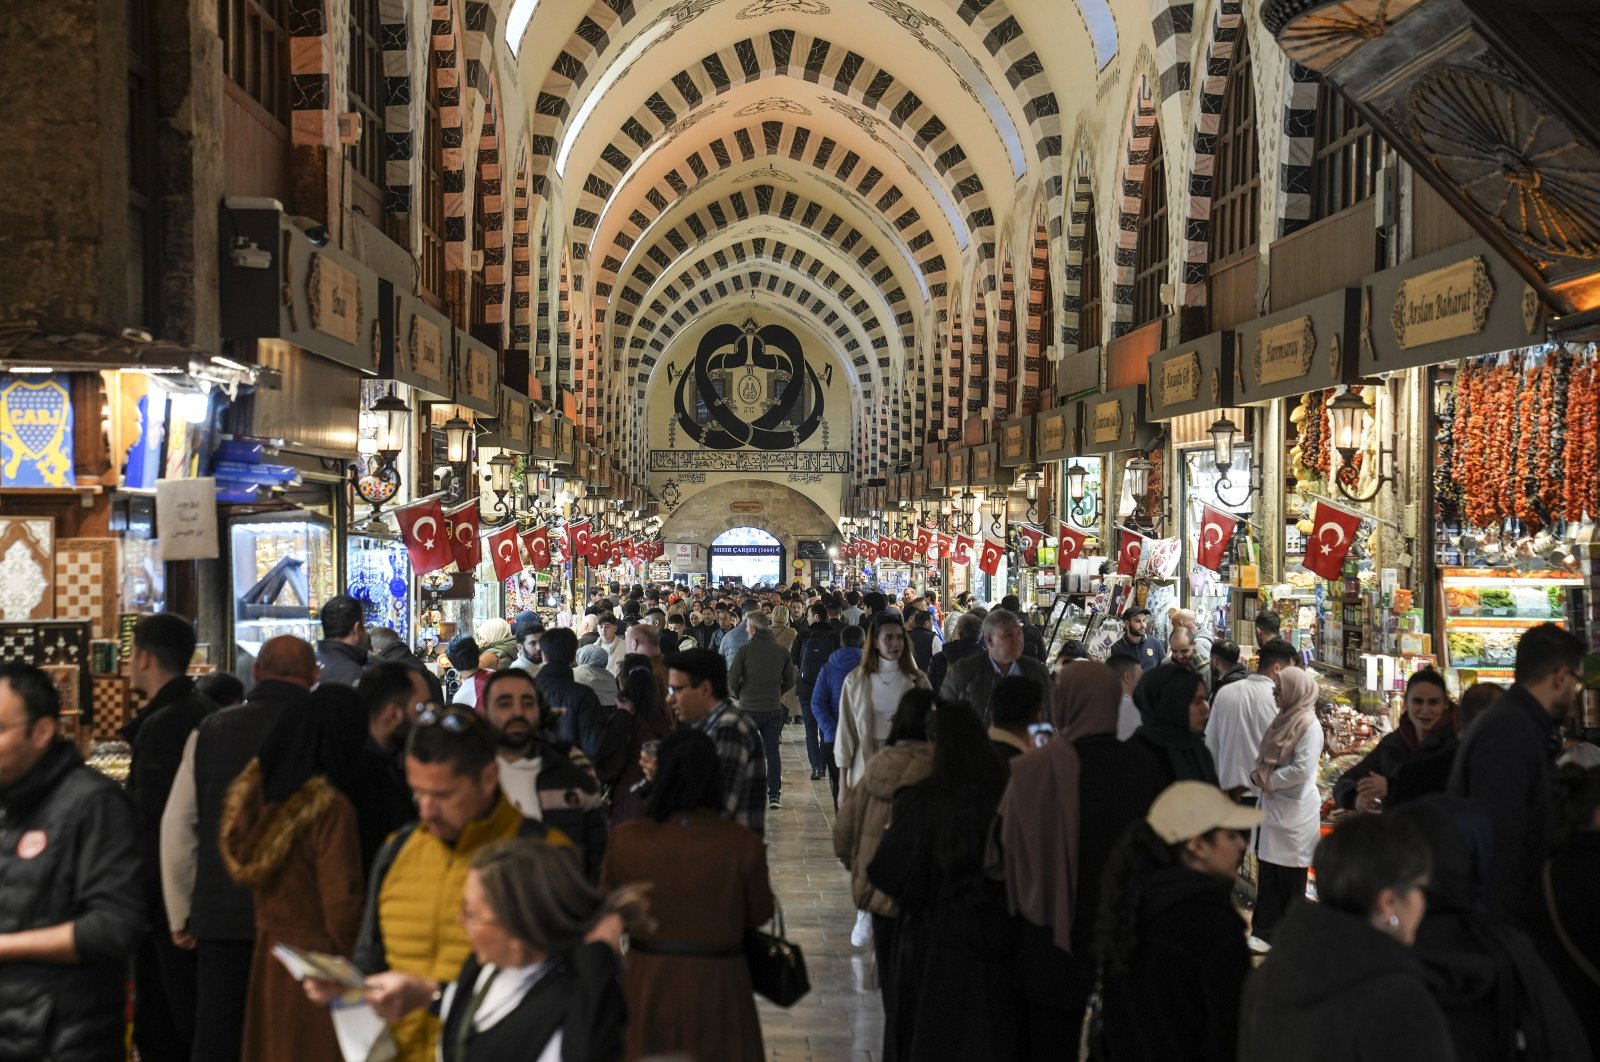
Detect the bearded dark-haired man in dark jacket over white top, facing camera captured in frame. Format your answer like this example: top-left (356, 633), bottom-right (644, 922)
top-left (478, 671), bottom-right (608, 881)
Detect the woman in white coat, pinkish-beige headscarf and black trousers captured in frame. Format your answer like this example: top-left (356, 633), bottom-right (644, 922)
top-left (1250, 667), bottom-right (1322, 940)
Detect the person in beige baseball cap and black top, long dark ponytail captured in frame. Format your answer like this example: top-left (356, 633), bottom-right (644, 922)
top-left (1096, 782), bottom-right (1261, 1062)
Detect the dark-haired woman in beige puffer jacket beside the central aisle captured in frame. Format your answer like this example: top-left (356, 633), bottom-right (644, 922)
top-left (834, 688), bottom-right (934, 998)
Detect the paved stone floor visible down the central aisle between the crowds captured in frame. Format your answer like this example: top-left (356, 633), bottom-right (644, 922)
top-left (757, 725), bottom-right (883, 1062)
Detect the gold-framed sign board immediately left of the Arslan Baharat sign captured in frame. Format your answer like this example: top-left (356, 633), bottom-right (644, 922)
top-left (1219, 288), bottom-right (1360, 405)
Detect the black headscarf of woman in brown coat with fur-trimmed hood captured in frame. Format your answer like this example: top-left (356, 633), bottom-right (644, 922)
top-left (261, 685), bottom-right (366, 806)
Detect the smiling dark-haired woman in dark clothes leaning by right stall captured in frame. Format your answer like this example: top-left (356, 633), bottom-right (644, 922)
top-left (1333, 667), bottom-right (1459, 811)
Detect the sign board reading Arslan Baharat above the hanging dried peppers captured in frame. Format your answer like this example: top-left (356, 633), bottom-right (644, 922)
top-left (1358, 238), bottom-right (1544, 376)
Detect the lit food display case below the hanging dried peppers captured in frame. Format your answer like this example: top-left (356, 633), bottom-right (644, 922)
top-left (1438, 568), bottom-right (1582, 686)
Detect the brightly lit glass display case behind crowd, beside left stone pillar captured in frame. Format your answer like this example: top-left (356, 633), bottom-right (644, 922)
top-left (229, 512), bottom-right (336, 659)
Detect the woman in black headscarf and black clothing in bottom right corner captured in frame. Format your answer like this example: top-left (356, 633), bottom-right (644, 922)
top-left (1394, 796), bottom-right (1594, 1062)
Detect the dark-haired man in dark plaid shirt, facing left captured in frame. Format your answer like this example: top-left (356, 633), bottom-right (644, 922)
top-left (659, 649), bottom-right (766, 835)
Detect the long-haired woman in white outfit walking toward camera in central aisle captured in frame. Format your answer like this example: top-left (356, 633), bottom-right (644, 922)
top-left (834, 613), bottom-right (933, 806)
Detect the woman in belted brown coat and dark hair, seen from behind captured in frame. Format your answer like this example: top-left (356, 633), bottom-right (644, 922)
top-left (600, 729), bottom-right (773, 1062)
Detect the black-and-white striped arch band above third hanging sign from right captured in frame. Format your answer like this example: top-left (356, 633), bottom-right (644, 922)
top-left (1178, 0), bottom-right (1245, 307)
